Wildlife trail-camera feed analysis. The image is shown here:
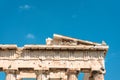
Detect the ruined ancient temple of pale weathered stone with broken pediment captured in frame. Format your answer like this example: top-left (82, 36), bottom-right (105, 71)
top-left (0, 34), bottom-right (108, 80)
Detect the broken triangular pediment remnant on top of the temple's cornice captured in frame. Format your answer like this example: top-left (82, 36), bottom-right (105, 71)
top-left (46, 34), bottom-right (106, 46)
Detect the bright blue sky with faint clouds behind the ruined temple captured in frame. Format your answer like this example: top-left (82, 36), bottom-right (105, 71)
top-left (0, 0), bottom-right (120, 80)
